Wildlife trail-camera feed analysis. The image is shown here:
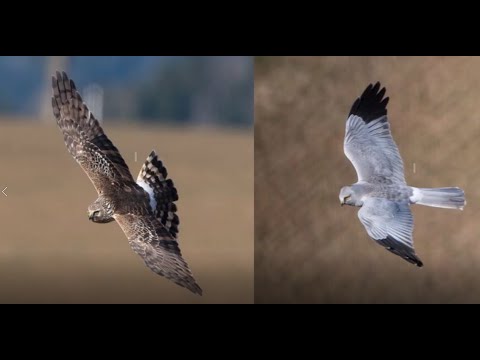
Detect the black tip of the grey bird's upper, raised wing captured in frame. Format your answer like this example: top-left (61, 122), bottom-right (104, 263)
top-left (348, 81), bottom-right (389, 123)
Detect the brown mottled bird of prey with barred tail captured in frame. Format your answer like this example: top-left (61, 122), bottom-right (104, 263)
top-left (52, 72), bottom-right (202, 295)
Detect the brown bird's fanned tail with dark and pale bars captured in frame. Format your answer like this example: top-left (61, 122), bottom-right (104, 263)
top-left (137, 150), bottom-right (180, 238)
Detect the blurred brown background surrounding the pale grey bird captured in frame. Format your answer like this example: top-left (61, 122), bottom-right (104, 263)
top-left (255, 57), bottom-right (480, 303)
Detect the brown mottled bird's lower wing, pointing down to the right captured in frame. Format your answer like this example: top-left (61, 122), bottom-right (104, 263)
top-left (114, 214), bottom-right (202, 295)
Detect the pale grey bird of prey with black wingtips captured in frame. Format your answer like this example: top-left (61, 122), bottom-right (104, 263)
top-left (339, 82), bottom-right (466, 267)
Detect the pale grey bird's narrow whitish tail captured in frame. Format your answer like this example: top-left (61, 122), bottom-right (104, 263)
top-left (410, 187), bottom-right (466, 210)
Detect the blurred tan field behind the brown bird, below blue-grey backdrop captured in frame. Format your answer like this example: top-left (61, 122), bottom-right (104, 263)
top-left (0, 119), bottom-right (253, 303)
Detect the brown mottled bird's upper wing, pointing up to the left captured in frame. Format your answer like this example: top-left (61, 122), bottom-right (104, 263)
top-left (52, 71), bottom-right (133, 193)
